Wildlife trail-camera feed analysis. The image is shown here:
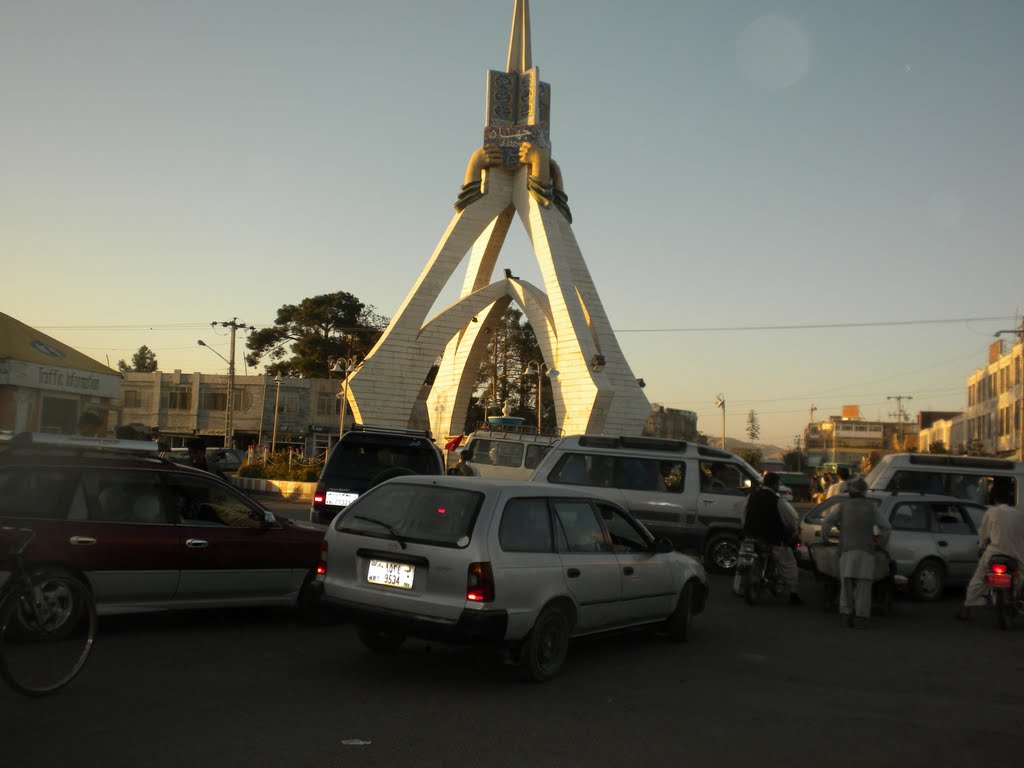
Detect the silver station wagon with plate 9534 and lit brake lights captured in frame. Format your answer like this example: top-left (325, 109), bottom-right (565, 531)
top-left (317, 476), bottom-right (708, 681)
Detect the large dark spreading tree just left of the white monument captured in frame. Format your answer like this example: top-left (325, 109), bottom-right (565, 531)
top-left (246, 291), bottom-right (388, 379)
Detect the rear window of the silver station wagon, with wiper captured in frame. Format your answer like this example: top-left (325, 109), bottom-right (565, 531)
top-left (334, 481), bottom-right (483, 548)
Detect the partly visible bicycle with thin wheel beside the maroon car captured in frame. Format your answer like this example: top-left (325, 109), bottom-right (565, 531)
top-left (0, 526), bottom-right (96, 696)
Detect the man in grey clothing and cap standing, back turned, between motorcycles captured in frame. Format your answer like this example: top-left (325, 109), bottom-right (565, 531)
top-left (821, 477), bottom-right (891, 627)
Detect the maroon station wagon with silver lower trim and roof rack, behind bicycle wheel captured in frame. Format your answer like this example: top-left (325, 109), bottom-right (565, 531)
top-left (0, 433), bottom-right (325, 618)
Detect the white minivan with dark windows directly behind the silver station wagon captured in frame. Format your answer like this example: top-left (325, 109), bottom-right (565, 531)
top-left (530, 435), bottom-right (760, 572)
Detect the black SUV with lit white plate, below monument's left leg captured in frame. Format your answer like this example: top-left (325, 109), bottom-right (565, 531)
top-left (309, 424), bottom-right (444, 524)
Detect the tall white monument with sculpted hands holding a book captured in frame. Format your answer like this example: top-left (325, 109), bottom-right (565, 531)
top-left (347, 0), bottom-right (650, 436)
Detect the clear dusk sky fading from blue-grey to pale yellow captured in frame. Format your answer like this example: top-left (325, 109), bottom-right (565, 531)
top-left (0, 0), bottom-right (1024, 446)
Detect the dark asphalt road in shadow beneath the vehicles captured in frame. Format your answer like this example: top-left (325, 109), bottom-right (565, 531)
top-left (0, 565), bottom-right (1024, 768)
